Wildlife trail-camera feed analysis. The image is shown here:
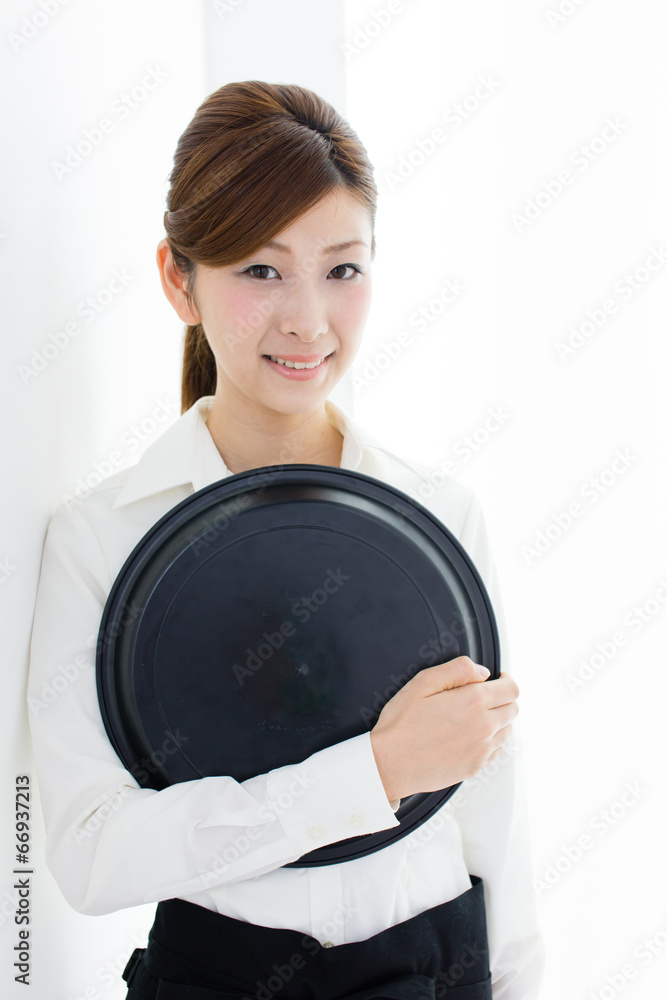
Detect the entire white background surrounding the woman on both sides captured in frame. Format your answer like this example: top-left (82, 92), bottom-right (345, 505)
top-left (0, 0), bottom-right (667, 1000)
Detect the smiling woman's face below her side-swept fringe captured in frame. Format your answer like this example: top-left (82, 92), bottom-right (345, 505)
top-left (180, 188), bottom-right (372, 413)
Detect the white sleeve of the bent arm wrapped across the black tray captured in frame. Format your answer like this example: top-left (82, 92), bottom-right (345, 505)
top-left (28, 505), bottom-right (398, 914)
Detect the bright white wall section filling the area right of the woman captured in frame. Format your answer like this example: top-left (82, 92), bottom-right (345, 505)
top-left (346, 0), bottom-right (667, 1000)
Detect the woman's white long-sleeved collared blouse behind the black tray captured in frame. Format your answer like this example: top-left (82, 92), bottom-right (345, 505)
top-left (28, 396), bottom-right (544, 1000)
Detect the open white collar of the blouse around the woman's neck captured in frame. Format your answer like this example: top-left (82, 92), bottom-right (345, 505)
top-left (112, 396), bottom-right (381, 510)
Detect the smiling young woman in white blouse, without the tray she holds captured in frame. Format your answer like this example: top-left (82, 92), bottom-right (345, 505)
top-left (28, 81), bottom-right (543, 1000)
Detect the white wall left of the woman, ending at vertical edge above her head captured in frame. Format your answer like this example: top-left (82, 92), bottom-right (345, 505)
top-left (0, 0), bottom-right (210, 1000)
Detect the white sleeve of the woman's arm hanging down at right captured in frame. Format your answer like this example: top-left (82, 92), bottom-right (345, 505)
top-left (450, 497), bottom-right (545, 1000)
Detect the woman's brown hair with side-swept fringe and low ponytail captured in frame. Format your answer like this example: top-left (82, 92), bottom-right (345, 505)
top-left (164, 80), bottom-right (377, 413)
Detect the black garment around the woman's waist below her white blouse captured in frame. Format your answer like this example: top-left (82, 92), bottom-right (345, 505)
top-left (123, 875), bottom-right (491, 1000)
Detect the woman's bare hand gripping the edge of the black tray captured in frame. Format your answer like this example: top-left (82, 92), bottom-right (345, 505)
top-left (371, 656), bottom-right (519, 801)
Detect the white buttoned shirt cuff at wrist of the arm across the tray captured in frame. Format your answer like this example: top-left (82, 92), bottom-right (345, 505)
top-left (267, 732), bottom-right (400, 857)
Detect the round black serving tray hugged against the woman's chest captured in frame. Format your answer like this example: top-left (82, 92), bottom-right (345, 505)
top-left (96, 464), bottom-right (500, 867)
